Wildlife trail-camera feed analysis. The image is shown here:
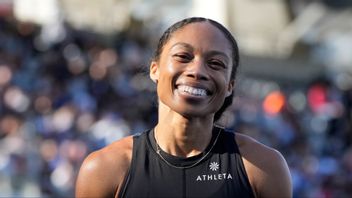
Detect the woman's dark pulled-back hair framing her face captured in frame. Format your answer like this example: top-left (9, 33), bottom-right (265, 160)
top-left (153, 17), bottom-right (239, 121)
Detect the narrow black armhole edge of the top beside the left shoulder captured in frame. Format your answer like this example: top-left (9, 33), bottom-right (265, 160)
top-left (115, 135), bottom-right (139, 198)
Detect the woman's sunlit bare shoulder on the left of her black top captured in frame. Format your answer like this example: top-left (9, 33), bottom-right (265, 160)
top-left (76, 136), bottom-right (133, 197)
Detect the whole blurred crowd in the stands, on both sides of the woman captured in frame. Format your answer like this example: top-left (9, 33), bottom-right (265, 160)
top-left (0, 17), bottom-right (352, 198)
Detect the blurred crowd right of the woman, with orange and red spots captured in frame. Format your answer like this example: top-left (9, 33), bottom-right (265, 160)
top-left (230, 78), bottom-right (352, 198)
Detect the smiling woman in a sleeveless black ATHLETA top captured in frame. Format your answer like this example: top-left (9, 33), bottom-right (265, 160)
top-left (76, 18), bottom-right (292, 198)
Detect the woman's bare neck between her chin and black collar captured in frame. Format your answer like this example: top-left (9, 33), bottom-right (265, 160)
top-left (154, 102), bottom-right (213, 157)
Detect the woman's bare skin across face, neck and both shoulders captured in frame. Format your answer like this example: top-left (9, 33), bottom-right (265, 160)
top-left (76, 22), bottom-right (292, 198)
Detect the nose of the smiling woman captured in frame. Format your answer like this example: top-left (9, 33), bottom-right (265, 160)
top-left (186, 60), bottom-right (209, 80)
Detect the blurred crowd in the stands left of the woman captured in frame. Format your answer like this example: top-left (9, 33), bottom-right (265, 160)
top-left (0, 17), bottom-right (156, 197)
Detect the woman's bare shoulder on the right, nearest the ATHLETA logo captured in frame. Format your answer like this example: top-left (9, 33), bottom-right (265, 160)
top-left (236, 133), bottom-right (292, 197)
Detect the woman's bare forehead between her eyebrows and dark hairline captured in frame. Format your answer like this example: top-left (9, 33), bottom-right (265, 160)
top-left (166, 22), bottom-right (232, 53)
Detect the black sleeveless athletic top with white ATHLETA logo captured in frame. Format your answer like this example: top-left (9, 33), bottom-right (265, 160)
top-left (118, 127), bottom-right (254, 198)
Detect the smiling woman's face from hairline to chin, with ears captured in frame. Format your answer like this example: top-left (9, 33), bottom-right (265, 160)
top-left (150, 22), bottom-right (234, 117)
